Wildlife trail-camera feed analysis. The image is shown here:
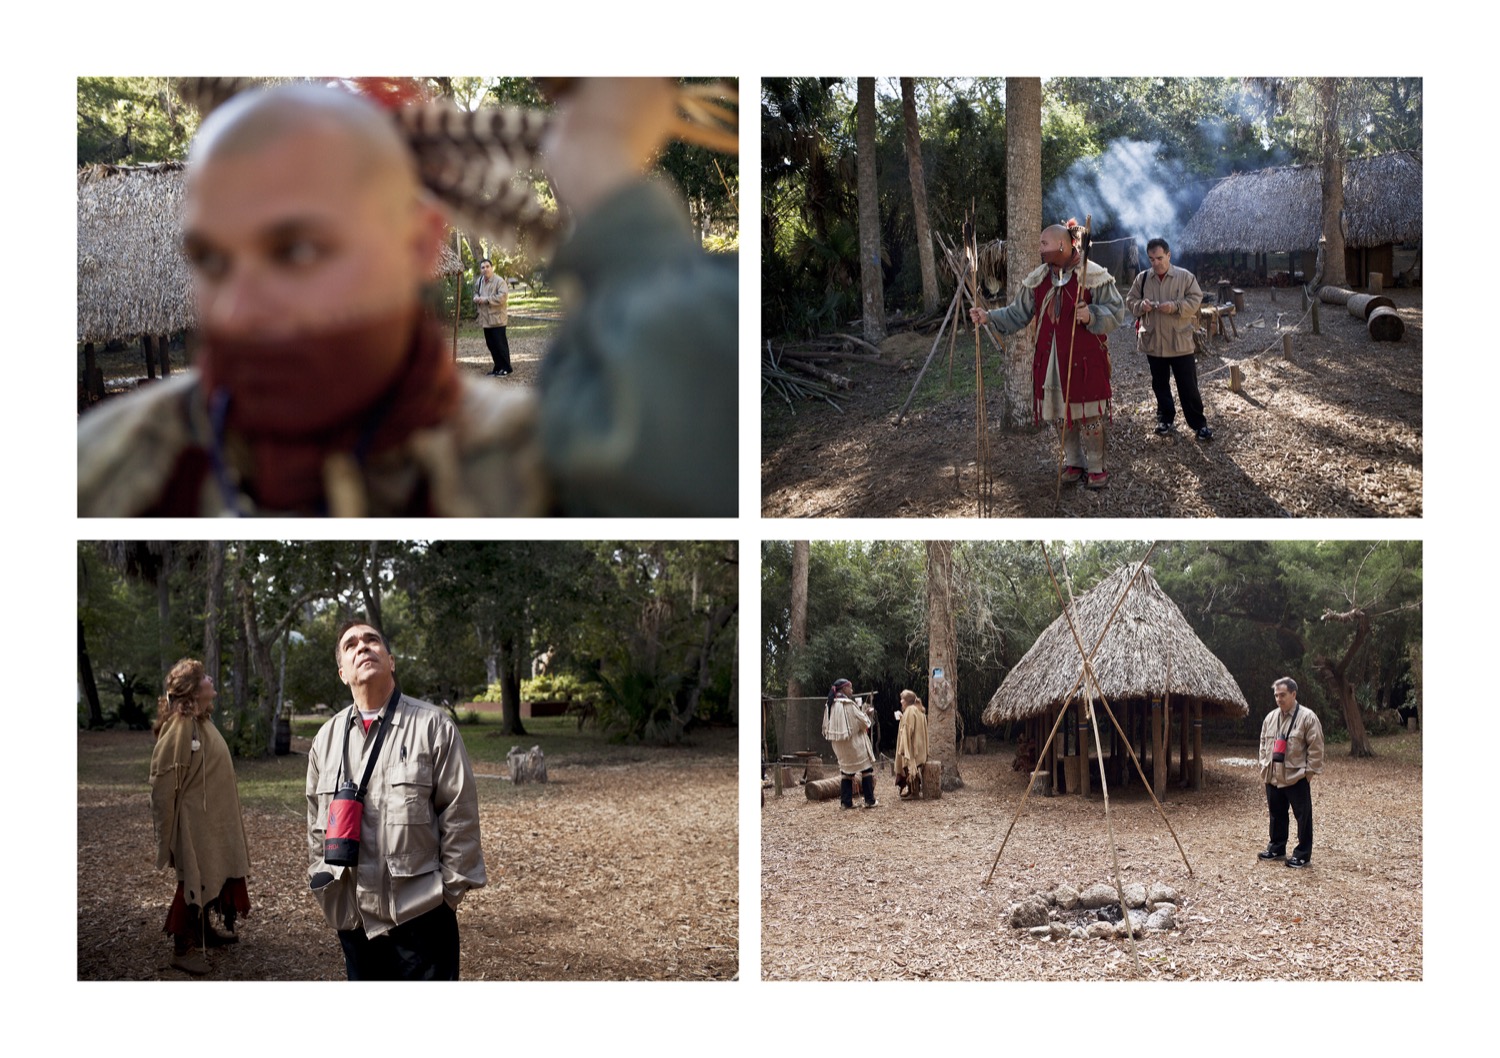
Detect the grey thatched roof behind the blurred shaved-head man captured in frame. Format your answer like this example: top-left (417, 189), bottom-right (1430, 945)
top-left (78, 162), bottom-right (464, 342)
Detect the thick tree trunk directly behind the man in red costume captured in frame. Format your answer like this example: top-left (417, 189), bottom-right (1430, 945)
top-left (1005, 77), bottom-right (1041, 426)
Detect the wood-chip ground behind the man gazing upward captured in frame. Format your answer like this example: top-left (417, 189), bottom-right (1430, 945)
top-left (78, 732), bottom-right (740, 980)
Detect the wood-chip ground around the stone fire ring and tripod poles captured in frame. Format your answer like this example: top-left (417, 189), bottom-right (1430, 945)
top-left (761, 732), bottom-right (1422, 980)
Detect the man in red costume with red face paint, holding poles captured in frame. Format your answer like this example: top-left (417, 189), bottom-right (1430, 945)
top-left (969, 221), bottom-right (1125, 489)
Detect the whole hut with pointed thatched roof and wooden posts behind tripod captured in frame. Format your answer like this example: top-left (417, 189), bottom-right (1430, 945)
top-left (981, 564), bottom-right (1250, 797)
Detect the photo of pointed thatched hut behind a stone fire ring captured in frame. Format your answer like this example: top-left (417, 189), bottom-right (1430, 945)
top-left (759, 540), bottom-right (1425, 981)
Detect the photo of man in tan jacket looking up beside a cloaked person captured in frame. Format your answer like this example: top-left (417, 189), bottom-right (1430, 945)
top-left (77, 540), bottom-right (740, 981)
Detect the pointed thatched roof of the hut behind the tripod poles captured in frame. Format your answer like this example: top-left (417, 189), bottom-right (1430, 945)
top-left (983, 566), bottom-right (1250, 726)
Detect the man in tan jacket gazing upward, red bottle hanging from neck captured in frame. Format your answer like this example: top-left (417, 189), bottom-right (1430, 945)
top-left (308, 621), bottom-right (486, 981)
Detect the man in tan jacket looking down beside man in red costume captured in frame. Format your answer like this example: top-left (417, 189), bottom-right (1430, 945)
top-left (1125, 239), bottom-right (1214, 441)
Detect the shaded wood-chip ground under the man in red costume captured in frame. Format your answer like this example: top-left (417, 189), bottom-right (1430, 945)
top-left (761, 288), bottom-right (1422, 518)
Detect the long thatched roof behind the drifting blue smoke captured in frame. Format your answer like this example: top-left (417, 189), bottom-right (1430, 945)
top-left (1179, 150), bottom-right (1422, 254)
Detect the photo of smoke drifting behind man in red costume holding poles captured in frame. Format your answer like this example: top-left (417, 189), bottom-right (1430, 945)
top-left (761, 77), bottom-right (1424, 518)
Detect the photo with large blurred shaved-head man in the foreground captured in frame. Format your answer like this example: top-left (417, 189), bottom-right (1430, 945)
top-left (77, 77), bottom-right (740, 518)
